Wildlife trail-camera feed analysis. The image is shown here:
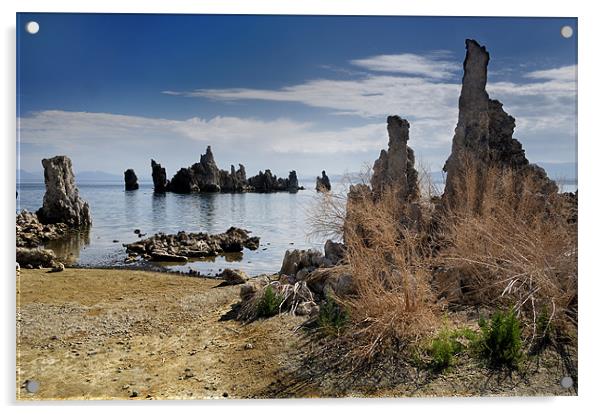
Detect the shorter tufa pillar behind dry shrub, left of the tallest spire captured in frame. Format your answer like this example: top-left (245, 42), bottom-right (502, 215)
top-left (370, 115), bottom-right (419, 201)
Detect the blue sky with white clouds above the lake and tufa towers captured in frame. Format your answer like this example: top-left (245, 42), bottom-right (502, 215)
top-left (17, 13), bottom-right (577, 177)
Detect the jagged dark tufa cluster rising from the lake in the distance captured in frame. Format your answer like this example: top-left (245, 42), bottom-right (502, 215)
top-left (151, 146), bottom-right (303, 194)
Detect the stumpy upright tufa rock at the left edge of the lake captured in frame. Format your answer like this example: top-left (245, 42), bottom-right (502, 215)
top-left (37, 155), bottom-right (92, 227)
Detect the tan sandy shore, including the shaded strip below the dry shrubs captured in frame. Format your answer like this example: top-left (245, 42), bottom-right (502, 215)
top-left (17, 269), bottom-right (576, 400)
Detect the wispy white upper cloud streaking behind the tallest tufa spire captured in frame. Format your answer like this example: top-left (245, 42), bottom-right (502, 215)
top-left (162, 58), bottom-right (577, 168)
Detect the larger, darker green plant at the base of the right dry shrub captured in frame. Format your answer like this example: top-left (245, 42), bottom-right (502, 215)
top-left (479, 310), bottom-right (523, 368)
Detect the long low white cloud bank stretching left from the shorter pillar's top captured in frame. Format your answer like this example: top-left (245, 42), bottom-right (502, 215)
top-left (19, 111), bottom-right (387, 154)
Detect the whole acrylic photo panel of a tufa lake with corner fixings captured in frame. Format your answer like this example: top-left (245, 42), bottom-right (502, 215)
top-left (16, 13), bottom-right (578, 400)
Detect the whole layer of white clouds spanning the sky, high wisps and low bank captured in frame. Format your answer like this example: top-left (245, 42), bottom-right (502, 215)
top-left (19, 53), bottom-right (577, 175)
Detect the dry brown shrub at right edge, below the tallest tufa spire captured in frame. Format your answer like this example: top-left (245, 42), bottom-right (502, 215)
top-left (437, 166), bottom-right (577, 344)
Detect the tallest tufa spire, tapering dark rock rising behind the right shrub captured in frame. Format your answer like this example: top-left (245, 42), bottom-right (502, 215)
top-left (443, 39), bottom-right (558, 211)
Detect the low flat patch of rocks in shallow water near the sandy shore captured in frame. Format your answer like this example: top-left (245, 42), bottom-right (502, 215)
top-left (124, 227), bottom-right (259, 263)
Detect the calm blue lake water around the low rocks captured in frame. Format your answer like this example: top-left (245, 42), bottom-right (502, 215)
top-left (17, 182), bottom-right (323, 275)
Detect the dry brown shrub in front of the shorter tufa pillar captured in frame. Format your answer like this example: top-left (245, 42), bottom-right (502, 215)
top-left (340, 191), bottom-right (437, 362)
